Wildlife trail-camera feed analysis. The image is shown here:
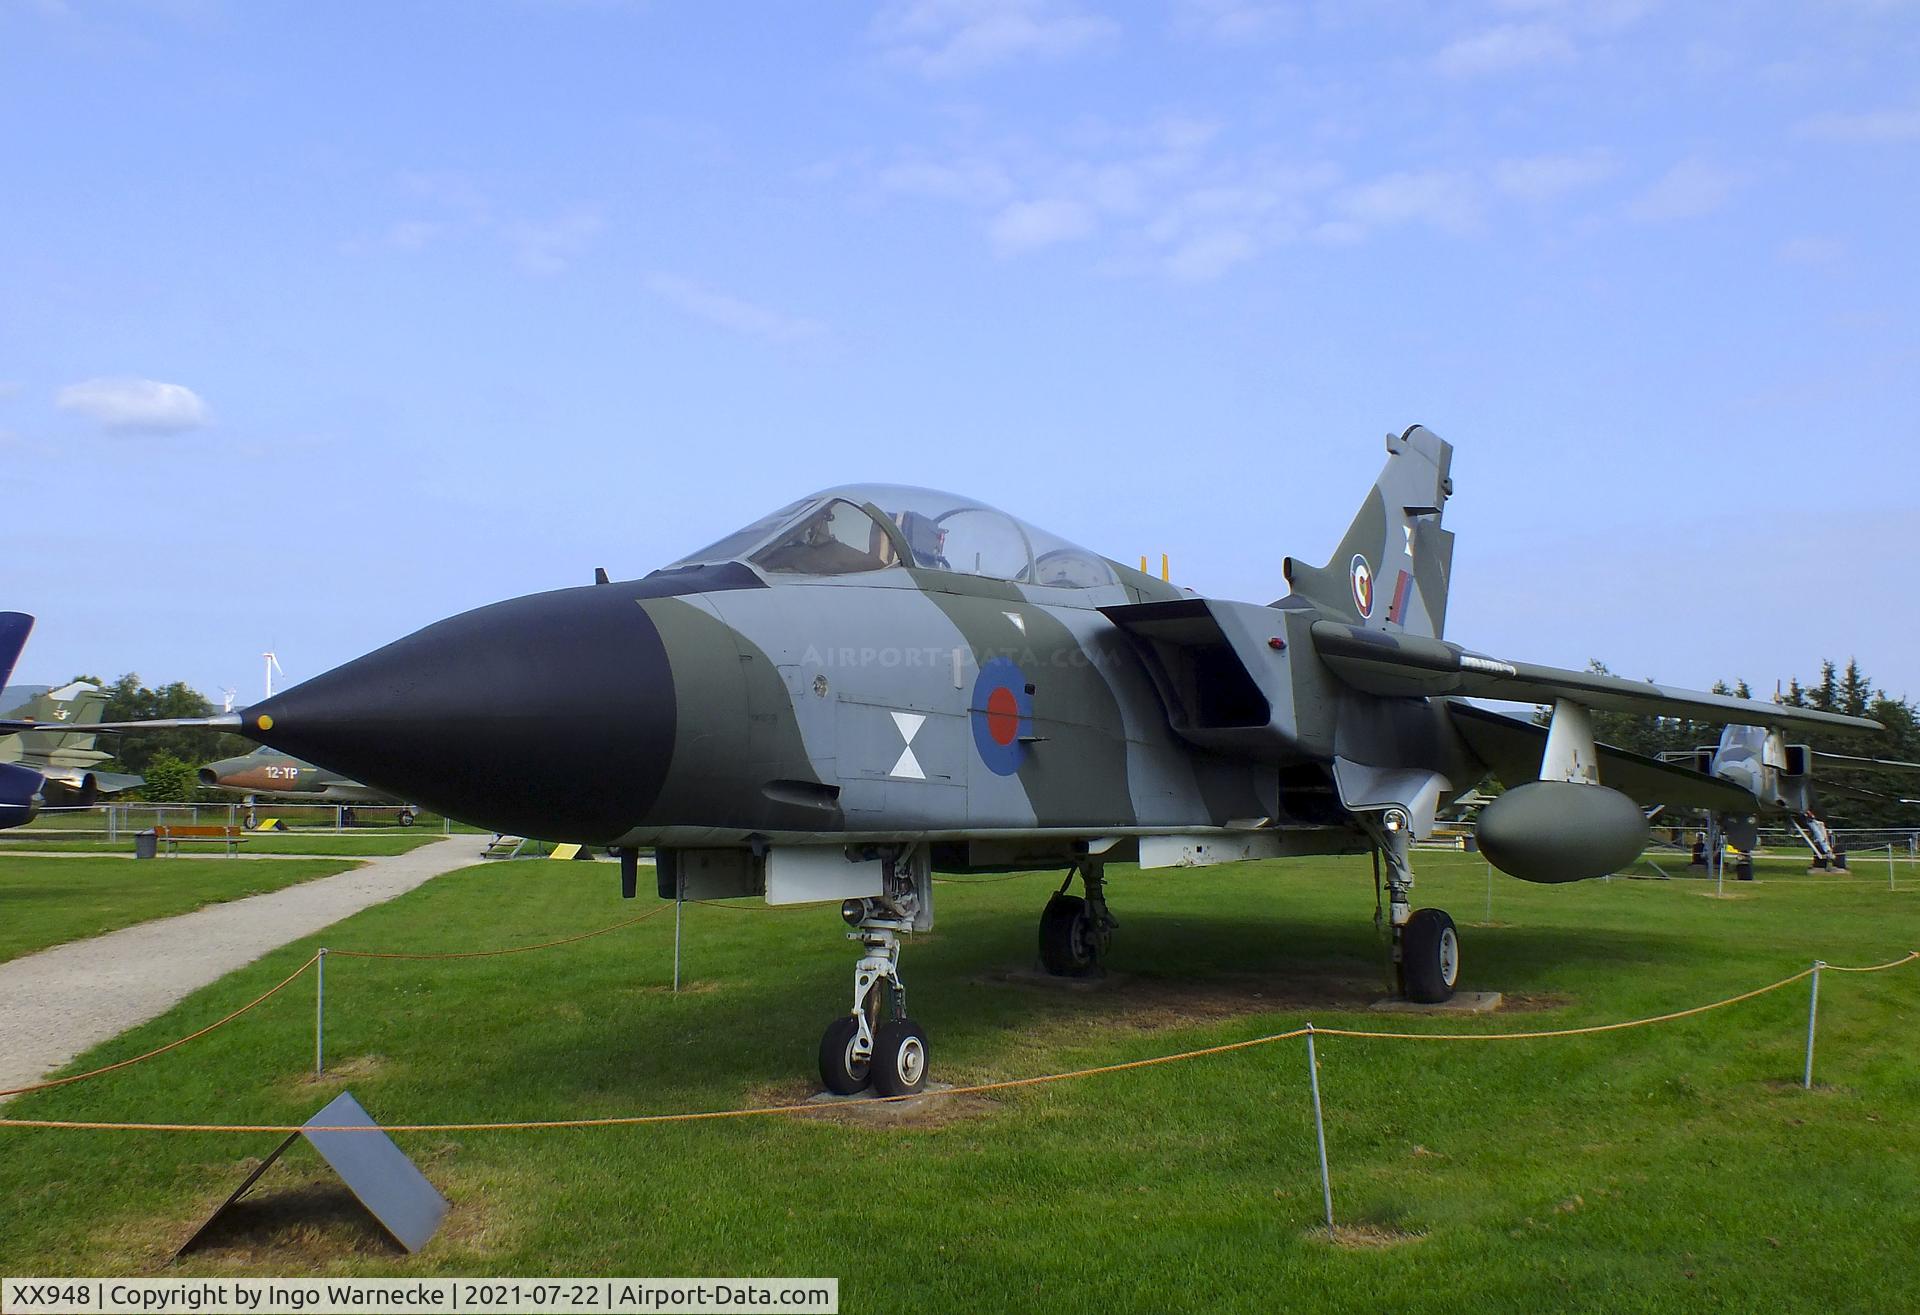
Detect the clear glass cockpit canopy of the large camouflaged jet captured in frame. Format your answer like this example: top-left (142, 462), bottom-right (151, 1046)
top-left (674, 484), bottom-right (1116, 589)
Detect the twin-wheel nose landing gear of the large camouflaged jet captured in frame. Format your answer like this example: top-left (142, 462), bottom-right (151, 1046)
top-left (820, 850), bottom-right (927, 1096)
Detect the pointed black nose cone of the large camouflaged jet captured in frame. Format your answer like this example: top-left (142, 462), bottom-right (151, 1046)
top-left (242, 586), bottom-right (674, 843)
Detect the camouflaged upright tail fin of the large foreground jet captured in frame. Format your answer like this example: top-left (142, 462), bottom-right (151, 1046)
top-left (1284, 424), bottom-right (1453, 639)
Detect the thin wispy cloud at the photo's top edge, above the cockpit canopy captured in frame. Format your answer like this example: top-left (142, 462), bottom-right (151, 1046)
top-left (874, 0), bottom-right (1119, 77)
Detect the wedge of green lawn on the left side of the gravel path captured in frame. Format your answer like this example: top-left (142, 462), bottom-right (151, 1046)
top-left (0, 854), bottom-right (353, 962)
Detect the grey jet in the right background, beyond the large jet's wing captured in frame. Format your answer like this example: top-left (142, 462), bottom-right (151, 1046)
top-left (1661, 726), bottom-right (1920, 881)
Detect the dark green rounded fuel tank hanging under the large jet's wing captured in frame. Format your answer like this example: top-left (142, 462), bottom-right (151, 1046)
top-left (1478, 781), bottom-right (1647, 885)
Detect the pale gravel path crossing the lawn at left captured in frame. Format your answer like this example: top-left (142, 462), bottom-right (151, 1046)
top-left (0, 835), bottom-right (486, 1090)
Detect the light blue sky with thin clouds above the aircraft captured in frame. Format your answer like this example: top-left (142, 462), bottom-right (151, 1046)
top-left (0, 0), bottom-right (1920, 701)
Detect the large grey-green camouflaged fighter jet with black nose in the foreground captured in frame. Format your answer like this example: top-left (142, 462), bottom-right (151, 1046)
top-left (93, 426), bottom-right (1876, 1096)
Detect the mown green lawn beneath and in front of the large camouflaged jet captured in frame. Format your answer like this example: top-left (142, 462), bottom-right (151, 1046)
top-left (0, 852), bottom-right (1920, 1311)
